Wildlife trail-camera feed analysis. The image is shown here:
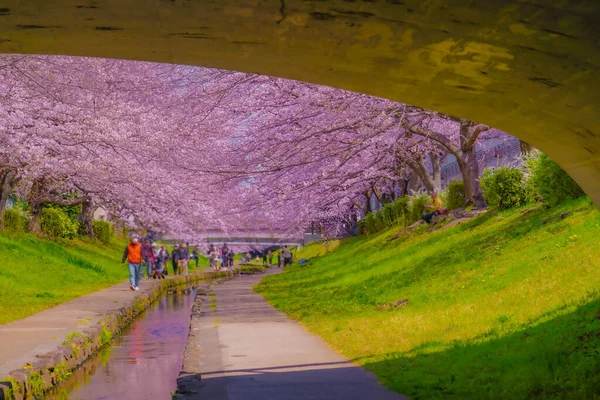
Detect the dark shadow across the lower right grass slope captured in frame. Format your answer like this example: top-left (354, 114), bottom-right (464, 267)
top-left (359, 294), bottom-right (600, 399)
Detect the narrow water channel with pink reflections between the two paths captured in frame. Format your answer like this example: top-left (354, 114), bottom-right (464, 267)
top-left (45, 291), bottom-right (194, 400)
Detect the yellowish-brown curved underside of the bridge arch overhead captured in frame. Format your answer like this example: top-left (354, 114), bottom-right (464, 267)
top-left (0, 0), bottom-right (600, 204)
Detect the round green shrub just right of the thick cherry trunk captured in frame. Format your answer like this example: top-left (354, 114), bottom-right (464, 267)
top-left (479, 167), bottom-right (527, 210)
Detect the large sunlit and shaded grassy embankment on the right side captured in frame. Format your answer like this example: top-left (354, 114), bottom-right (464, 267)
top-left (256, 198), bottom-right (600, 399)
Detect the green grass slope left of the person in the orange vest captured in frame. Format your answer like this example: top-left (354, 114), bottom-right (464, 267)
top-left (0, 231), bottom-right (129, 324)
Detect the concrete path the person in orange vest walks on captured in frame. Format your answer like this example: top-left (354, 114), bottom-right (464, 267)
top-left (0, 268), bottom-right (199, 379)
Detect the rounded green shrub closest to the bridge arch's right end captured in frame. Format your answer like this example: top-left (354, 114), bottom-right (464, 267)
top-left (525, 152), bottom-right (585, 205)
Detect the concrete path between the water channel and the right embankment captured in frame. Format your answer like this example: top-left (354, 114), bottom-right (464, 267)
top-left (177, 269), bottom-right (405, 400)
